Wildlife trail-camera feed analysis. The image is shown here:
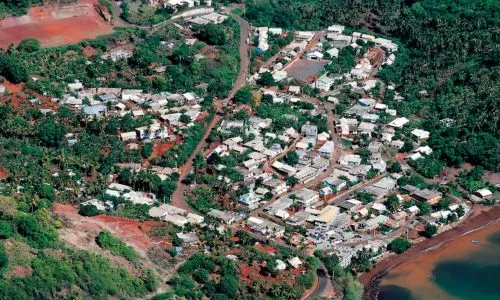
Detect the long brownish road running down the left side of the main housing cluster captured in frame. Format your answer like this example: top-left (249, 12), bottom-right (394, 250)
top-left (172, 10), bottom-right (250, 211)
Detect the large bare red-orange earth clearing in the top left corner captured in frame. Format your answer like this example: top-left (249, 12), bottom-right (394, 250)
top-left (0, 0), bottom-right (113, 48)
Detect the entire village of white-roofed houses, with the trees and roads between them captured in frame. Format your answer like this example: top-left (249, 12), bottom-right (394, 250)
top-left (0, 0), bottom-right (500, 299)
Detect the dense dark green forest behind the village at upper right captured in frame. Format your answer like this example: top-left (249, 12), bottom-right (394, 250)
top-left (245, 0), bottom-right (500, 170)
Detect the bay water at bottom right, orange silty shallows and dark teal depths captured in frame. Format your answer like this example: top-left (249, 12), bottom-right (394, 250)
top-left (377, 222), bottom-right (500, 300)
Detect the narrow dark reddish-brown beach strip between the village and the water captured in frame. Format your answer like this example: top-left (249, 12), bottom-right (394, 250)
top-left (358, 206), bottom-right (500, 299)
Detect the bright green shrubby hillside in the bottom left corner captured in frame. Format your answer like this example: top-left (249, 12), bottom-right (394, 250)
top-left (0, 196), bottom-right (158, 299)
